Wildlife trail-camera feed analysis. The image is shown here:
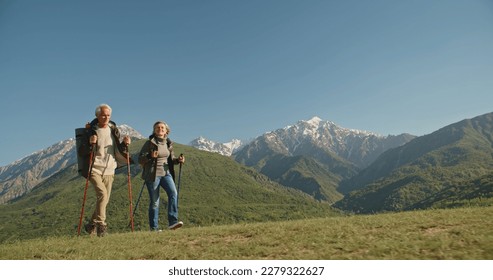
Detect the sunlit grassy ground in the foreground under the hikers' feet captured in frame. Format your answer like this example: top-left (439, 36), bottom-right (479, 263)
top-left (0, 207), bottom-right (493, 260)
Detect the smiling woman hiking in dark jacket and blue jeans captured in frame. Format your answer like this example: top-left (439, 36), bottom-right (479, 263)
top-left (139, 121), bottom-right (185, 231)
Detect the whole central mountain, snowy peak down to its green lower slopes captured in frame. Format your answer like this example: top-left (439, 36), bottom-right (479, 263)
top-left (233, 117), bottom-right (415, 202)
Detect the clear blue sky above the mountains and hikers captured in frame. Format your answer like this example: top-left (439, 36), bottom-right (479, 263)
top-left (0, 0), bottom-right (493, 166)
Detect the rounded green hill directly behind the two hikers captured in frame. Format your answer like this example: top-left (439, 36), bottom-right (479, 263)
top-left (0, 140), bottom-right (337, 241)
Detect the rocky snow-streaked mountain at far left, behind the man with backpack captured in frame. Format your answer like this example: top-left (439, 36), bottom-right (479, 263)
top-left (0, 124), bottom-right (144, 204)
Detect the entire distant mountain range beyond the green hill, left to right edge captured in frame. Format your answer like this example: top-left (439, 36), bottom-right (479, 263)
top-left (0, 113), bottom-right (493, 217)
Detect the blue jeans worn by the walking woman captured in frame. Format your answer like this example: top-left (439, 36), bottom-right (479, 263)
top-left (146, 171), bottom-right (178, 230)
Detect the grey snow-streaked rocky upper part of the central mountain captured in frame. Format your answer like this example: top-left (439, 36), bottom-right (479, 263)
top-left (237, 117), bottom-right (415, 168)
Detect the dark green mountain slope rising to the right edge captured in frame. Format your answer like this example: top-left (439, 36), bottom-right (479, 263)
top-left (335, 113), bottom-right (493, 213)
